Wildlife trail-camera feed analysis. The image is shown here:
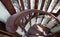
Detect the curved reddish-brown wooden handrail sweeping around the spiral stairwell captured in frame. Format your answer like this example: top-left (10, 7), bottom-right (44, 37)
top-left (6, 9), bottom-right (60, 33)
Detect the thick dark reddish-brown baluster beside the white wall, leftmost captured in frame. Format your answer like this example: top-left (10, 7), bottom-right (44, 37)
top-left (1, 0), bottom-right (16, 15)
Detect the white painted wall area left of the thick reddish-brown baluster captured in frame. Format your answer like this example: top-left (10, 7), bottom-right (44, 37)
top-left (0, 1), bottom-right (10, 23)
